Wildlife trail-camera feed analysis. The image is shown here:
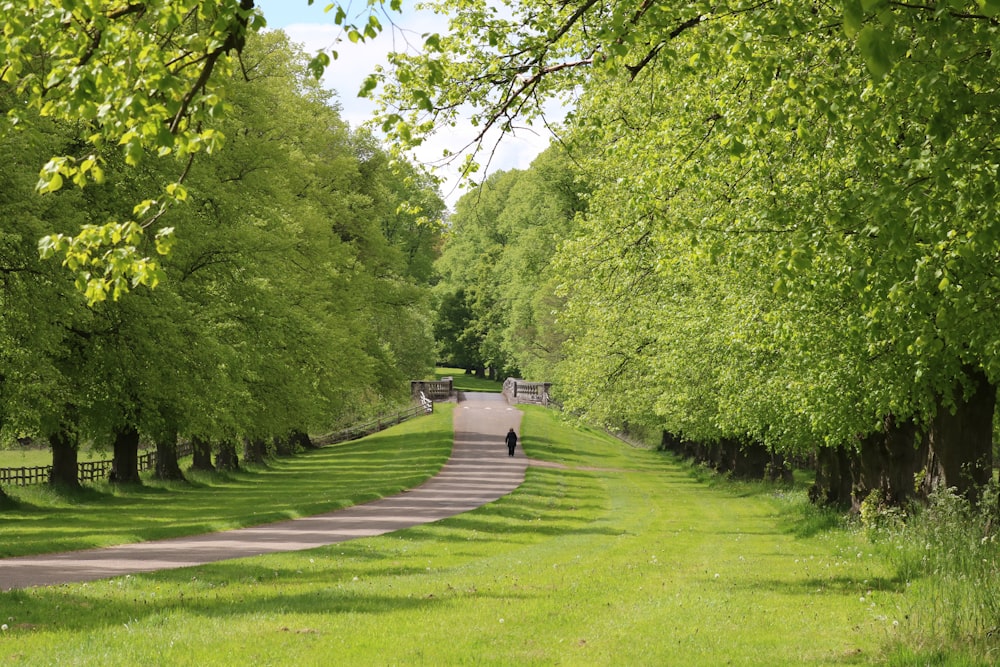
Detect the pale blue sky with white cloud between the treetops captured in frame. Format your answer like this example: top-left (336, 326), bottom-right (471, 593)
top-left (255, 0), bottom-right (549, 208)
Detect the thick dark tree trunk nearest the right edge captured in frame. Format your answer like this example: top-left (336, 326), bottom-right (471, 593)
top-left (923, 368), bottom-right (996, 502)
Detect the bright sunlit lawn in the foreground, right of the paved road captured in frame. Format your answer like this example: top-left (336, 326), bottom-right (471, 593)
top-left (0, 407), bottom-right (985, 666)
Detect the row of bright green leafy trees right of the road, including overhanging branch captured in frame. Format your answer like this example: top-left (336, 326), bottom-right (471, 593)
top-left (406, 0), bottom-right (1000, 506)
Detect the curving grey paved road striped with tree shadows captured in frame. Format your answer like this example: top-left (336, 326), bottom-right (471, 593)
top-left (0, 393), bottom-right (529, 590)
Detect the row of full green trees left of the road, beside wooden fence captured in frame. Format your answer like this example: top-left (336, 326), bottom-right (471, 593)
top-left (0, 28), bottom-right (444, 485)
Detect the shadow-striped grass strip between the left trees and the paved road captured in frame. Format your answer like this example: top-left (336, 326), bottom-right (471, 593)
top-left (0, 404), bottom-right (453, 557)
